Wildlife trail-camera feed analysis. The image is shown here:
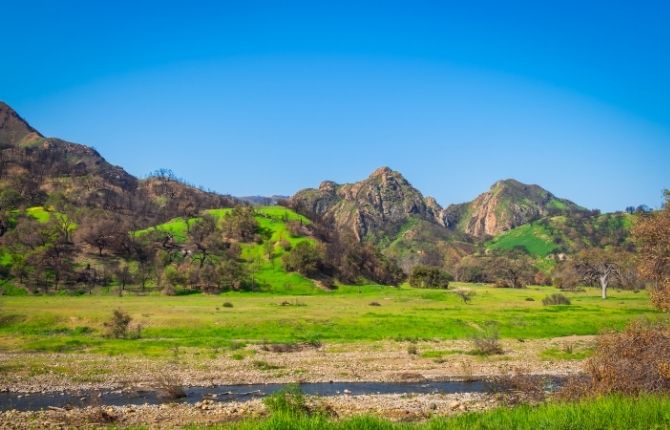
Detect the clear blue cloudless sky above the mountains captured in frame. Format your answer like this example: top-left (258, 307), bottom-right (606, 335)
top-left (0, 0), bottom-right (670, 210)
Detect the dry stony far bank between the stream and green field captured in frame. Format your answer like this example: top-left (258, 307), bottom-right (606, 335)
top-left (0, 336), bottom-right (595, 393)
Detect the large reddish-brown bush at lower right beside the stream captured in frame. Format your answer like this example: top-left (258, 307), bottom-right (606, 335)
top-left (561, 321), bottom-right (670, 398)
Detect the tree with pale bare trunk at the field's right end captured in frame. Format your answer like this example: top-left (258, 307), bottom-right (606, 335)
top-left (574, 248), bottom-right (621, 299)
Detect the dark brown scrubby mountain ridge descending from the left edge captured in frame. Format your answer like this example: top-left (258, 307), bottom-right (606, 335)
top-left (0, 102), bottom-right (237, 223)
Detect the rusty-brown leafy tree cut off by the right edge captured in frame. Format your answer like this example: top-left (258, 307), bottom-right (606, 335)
top-left (633, 190), bottom-right (670, 312)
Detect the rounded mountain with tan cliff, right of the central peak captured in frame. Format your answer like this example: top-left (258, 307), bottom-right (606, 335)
top-left (443, 179), bottom-right (587, 238)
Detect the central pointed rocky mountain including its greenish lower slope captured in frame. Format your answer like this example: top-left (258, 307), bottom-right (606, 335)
top-left (289, 167), bottom-right (474, 272)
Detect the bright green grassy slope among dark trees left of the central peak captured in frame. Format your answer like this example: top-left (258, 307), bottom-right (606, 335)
top-left (135, 206), bottom-right (316, 294)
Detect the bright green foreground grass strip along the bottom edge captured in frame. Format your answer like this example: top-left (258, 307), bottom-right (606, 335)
top-left (188, 396), bottom-right (670, 430)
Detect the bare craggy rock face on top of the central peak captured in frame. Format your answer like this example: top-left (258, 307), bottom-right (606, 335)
top-left (290, 167), bottom-right (442, 240)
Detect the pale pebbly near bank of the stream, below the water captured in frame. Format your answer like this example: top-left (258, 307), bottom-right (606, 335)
top-left (0, 393), bottom-right (498, 430)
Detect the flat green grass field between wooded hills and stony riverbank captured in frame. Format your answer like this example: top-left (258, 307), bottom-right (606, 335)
top-left (0, 283), bottom-right (659, 356)
